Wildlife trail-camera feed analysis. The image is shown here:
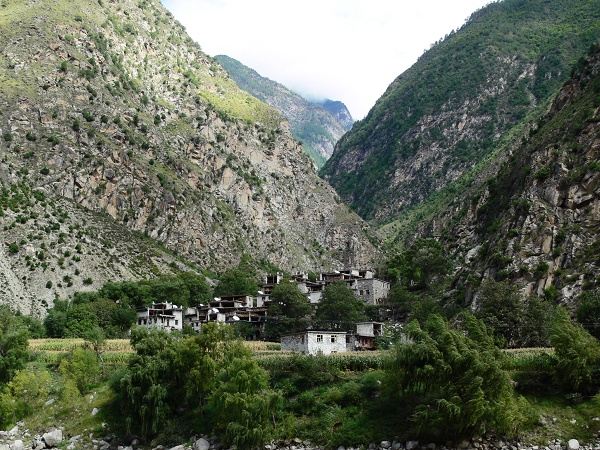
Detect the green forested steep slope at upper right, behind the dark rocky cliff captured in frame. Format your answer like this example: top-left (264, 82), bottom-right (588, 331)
top-left (321, 0), bottom-right (600, 223)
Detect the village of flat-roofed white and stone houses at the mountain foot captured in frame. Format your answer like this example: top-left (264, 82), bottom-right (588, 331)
top-left (137, 269), bottom-right (390, 355)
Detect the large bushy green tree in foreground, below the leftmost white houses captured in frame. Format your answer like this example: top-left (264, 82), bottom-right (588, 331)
top-left (111, 323), bottom-right (256, 435)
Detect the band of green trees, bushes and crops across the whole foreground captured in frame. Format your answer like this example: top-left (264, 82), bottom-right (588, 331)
top-left (0, 300), bottom-right (600, 448)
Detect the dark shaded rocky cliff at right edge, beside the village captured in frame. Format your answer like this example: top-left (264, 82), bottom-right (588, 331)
top-left (421, 47), bottom-right (600, 304)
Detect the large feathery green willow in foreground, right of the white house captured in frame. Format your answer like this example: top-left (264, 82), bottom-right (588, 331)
top-left (385, 315), bottom-right (524, 439)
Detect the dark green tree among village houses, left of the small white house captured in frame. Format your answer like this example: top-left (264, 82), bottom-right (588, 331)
top-left (265, 280), bottom-right (312, 339)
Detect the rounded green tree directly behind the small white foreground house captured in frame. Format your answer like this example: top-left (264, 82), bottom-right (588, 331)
top-left (315, 281), bottom-right (365, 331)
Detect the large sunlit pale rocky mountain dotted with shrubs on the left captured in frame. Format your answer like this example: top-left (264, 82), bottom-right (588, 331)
top-left (0, 0), bottom-right (376, 315)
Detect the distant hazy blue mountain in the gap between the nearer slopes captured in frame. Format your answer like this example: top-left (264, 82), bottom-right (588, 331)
top-left (215, 55), bottom-right (353, 167)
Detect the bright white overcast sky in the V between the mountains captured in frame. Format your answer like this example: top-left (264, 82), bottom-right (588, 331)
top-left (162, 0), bottom-right (490, 119)
